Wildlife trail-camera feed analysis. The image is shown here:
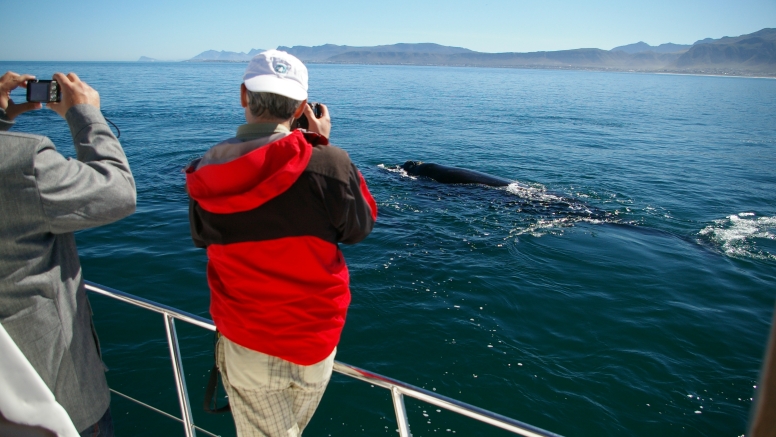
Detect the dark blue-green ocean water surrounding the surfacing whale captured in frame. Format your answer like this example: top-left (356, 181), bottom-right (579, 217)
top-left (0, 62), bottom-right (776, 437)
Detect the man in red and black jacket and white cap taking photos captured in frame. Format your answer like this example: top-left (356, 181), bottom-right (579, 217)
top-left (186, 50), bottom-right (377, 437)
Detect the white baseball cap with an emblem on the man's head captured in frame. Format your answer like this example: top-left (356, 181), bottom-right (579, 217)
top-left (243, 50), bottom-right (307, 101)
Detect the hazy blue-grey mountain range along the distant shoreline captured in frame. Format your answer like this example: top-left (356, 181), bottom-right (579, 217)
top-left (141, 28), bottom-right (776, 77)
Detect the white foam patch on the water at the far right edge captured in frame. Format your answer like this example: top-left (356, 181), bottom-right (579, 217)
top-left (698, 212), bottom-right (776, 260)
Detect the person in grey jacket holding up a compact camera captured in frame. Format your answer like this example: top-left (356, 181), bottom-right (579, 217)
top-left (0, 72), bottom-right (137, 437)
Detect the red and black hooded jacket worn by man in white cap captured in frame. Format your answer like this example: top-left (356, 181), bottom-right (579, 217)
top-left (186, 130), bottom-right (377, 365)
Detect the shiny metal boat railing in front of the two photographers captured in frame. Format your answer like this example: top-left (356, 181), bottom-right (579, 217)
top-left (84, 281), bottom-right (559, 437)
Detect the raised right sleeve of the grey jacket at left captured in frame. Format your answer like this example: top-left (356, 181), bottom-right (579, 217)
top-left (34, 104), bottom-right (137, 234)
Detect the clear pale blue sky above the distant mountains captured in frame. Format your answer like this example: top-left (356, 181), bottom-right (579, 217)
top-left (0, 0), bottom-right (776, 61)
